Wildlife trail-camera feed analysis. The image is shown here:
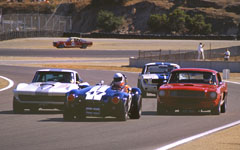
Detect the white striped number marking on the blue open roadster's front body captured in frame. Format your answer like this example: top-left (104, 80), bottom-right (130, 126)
top-left (86, 86), bottom-right (108, 101)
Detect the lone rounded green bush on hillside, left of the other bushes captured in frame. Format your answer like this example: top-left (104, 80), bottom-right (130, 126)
top-left (97, 10), bottom-right (123, 32)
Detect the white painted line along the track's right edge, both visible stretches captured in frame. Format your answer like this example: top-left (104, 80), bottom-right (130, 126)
top-left (155, 80), bottom-right (240, 150)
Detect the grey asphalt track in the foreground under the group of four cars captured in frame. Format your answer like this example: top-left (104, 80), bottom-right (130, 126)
top-left (0, 66), bottom-right (240, 150)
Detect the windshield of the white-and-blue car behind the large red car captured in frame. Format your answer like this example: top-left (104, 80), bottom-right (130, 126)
top-left (146, 65), bottom-right (175, 74)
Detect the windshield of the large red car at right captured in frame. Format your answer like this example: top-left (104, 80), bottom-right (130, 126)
top-left (169, 71), bottom-right (216, 85)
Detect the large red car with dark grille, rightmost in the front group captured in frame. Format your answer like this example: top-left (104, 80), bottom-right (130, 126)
top-left (157, 68), bottom-right (228, 115)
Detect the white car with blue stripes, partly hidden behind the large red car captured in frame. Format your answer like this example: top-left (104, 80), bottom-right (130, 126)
top-left (138, 62), bottom-right (180, 97)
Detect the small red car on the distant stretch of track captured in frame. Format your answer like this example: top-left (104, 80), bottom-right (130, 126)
top-left (53, 37), bottom-right (93, 48)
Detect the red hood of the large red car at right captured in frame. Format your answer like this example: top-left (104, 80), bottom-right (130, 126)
top-left (160, 83), bottom-right (216, 91)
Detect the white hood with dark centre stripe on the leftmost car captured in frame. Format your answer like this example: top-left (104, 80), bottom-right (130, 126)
top-left (14, 82), bottom-right (78, 95)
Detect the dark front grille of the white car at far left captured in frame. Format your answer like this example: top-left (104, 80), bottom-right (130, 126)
top-left (19, 95), bottom-right (66, 102)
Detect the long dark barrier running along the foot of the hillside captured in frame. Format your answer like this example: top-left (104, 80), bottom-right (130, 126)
top-left (0, 30), bottom-right (240, 40)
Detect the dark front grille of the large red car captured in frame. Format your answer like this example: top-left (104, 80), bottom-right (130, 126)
top-left (170, 90), bottom-right (205, 98)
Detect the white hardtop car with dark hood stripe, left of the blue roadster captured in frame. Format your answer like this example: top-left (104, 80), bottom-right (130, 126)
top-left (13, 69), bottom-right (89, 113)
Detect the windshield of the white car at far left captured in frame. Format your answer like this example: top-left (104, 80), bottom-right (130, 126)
top-left (33, 71), bottom-right (74, 83)
